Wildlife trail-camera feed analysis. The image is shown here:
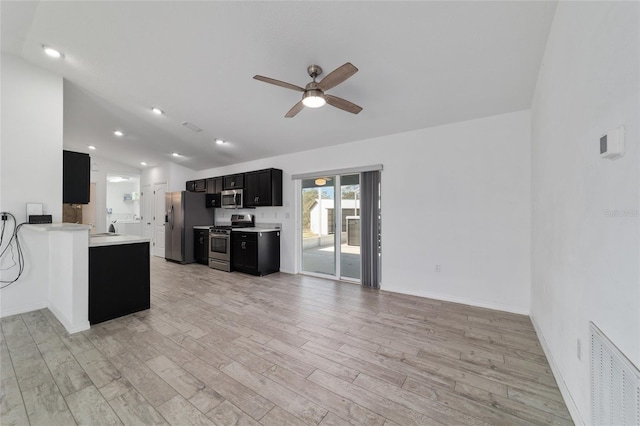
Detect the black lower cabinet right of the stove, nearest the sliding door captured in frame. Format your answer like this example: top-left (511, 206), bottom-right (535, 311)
top-left (231, 231), bottom-right (280, 276)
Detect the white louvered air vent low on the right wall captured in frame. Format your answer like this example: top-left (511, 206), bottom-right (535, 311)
top-left (589, 322), bottom-right (640, 426)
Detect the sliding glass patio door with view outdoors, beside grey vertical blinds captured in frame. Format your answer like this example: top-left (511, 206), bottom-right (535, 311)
top-left (301, 173), bottom-right (361, 282)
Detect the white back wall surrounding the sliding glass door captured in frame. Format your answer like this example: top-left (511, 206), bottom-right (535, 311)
top-left (197, 111), bottom-right (531, 313)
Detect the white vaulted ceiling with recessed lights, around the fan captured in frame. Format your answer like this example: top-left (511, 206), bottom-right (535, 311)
top-left (1, 1), bottom-right (556, 170)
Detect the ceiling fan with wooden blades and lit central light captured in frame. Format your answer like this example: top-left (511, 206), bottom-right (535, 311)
top-left (253, 62), bottom-right (362, 118)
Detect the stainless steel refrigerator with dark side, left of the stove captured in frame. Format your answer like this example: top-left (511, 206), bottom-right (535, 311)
top-left (164, 191), bottom-right (213, 263)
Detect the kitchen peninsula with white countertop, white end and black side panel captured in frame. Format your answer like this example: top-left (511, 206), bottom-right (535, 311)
top-left (22, 223), bottom-right (150, 333)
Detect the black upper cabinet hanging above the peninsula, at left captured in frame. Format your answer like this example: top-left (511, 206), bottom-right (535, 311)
top-left (62, 151), bottom-right (91, 204)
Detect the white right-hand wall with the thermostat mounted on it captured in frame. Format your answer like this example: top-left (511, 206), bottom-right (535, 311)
top-left (531, 2), bottom-right (640, 424)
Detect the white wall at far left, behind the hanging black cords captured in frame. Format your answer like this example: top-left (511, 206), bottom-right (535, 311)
top-left (0, 54), bottom-right (63, 316)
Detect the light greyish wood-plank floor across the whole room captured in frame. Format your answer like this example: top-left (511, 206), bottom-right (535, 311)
top-left (0, 258), bottom-right (572, 426)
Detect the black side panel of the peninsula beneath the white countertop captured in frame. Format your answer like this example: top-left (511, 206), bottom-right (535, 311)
top-left (89, 242), bottom-right (151, 324)
